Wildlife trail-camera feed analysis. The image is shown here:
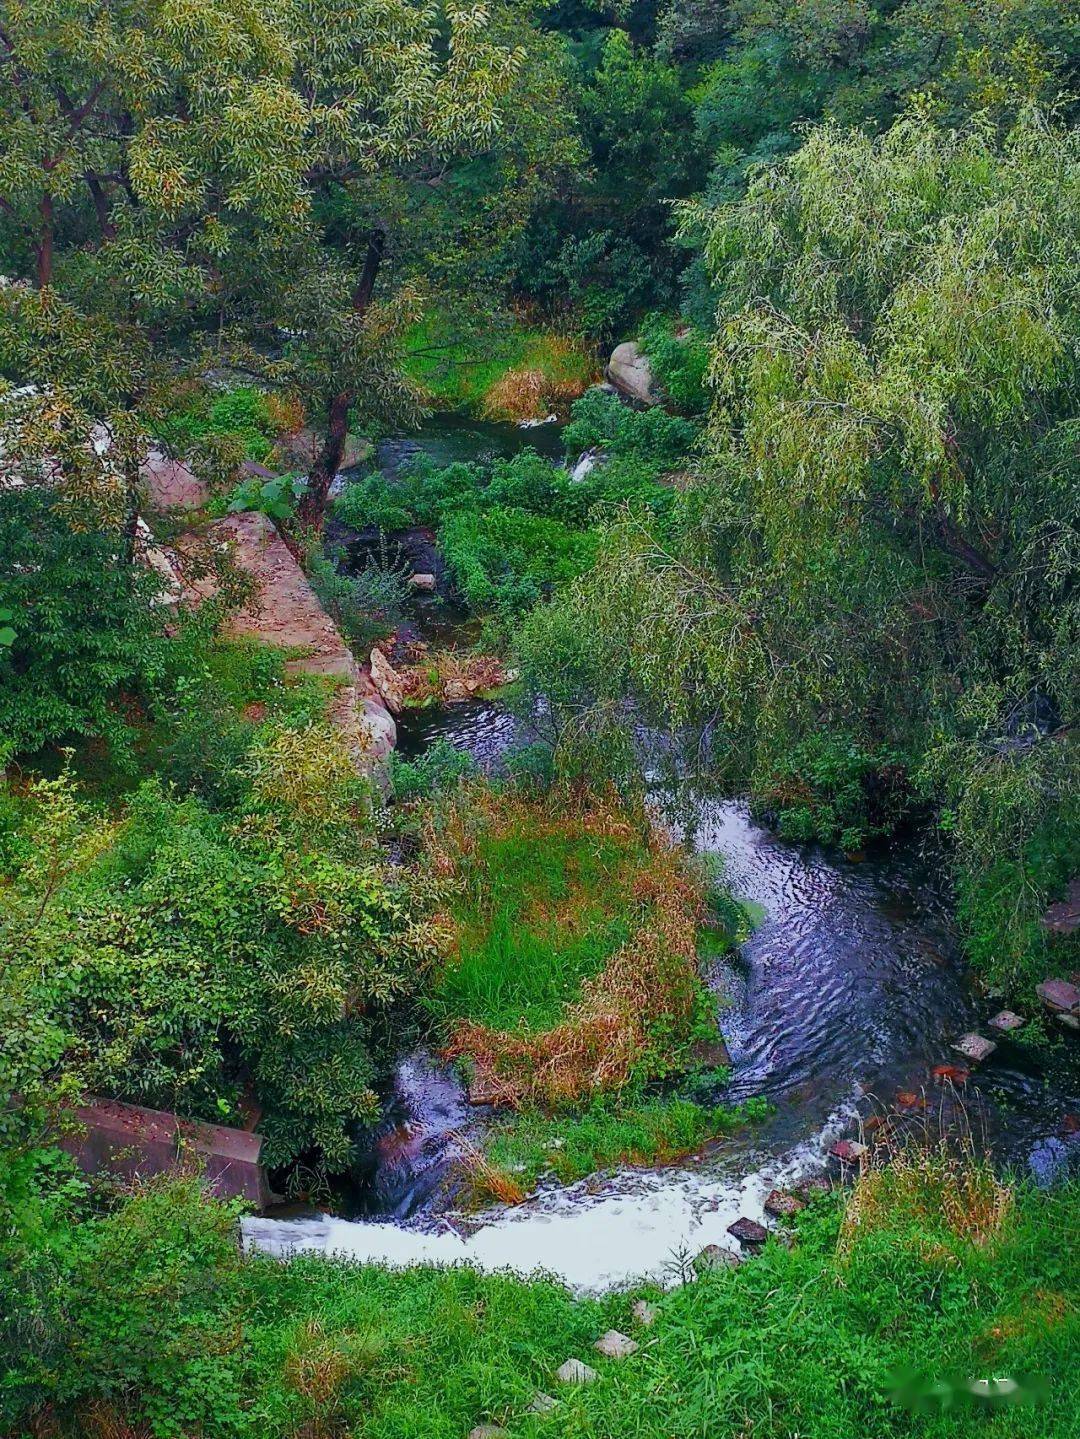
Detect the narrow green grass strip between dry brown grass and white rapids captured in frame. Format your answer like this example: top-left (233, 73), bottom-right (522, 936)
top-left (485, 1072), bottom-right (768, 1191)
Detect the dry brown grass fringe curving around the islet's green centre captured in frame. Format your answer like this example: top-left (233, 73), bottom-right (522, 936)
top-left (439, 791), bottom-right (706, 1108)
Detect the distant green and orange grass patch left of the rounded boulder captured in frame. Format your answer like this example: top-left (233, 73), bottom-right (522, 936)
top-left (406, 311), bottom-right (595, 414)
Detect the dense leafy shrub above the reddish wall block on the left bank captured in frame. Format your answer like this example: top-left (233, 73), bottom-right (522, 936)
top-left (0, 754), bottom-right (436, 1164)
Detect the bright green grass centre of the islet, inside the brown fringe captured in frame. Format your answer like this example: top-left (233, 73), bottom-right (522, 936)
top-left (429, 817), bottom-right (644, 1032)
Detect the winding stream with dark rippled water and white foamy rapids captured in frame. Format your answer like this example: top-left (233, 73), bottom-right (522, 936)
top-left (243, 417), bottom-right (1080, 1292)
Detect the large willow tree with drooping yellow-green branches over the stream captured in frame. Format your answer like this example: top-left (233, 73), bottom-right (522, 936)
top-left (526, 111), bottom-right (1080, 974)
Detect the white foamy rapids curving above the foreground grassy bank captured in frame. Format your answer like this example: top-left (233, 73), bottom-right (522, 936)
top-left (242, 1101), bottom-right (854, 1294)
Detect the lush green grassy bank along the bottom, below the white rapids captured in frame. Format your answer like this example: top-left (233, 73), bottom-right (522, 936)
top-left (0, 1184), bottom-right (1080, 1439)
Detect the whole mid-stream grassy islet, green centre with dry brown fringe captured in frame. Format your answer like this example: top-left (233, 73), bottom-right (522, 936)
top-left (427, 787), bottom-right (727, 1108)
